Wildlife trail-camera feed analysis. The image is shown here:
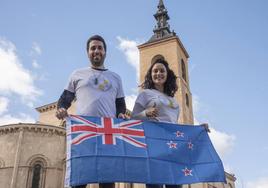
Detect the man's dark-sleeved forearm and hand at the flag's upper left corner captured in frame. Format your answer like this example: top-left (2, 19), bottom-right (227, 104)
top-left (56, 90), bottom-right (75, 119)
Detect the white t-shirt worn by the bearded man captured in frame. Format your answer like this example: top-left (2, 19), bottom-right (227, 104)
top-left (65, 67), bottom-right (124, 117)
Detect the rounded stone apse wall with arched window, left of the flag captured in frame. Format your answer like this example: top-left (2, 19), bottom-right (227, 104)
top-left (0, 124), bottom-right (65, 188)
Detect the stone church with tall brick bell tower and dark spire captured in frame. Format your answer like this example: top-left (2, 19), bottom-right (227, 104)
top-left (0, 0), bottom-right (236, 188)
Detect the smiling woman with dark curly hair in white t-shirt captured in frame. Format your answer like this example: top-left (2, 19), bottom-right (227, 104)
top-left (132, 59), bottom-right (181, 188)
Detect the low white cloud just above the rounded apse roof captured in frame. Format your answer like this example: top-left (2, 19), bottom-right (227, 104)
top-left (0, 113), bottom-right (36, 125)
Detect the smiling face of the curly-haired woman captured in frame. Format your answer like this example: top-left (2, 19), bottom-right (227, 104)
top-left (151, 63), bottom-right (167, 86)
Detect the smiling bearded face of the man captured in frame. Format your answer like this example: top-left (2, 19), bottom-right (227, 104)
top-left (88, 40), bottom-right (106, 67)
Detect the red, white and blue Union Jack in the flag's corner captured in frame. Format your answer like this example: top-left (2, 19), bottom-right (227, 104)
top-left (70, 115), bottom-right (146, 148)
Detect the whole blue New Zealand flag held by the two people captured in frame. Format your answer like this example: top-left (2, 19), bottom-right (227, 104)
top-left (65, 115), bottom-right (226, 186)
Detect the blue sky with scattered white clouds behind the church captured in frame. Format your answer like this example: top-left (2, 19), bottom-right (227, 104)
top-left (0, 0), bottom-right (268, 188)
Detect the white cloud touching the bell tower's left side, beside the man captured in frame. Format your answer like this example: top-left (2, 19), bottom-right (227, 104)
top-left (117, 36), bottom-right (140, 81)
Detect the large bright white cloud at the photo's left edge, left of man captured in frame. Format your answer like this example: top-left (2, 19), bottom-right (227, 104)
top-left (0, 38), bottom-right (41, 101)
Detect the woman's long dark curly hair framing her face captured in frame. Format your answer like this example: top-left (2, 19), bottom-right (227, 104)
top-left (141, 59), bottom-right (178, 97)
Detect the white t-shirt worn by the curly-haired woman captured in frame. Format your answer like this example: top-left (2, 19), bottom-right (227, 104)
top-left (132, 89), bottom-right (179, 123)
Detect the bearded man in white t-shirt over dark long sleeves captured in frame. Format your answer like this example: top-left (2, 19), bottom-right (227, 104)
top-left (56, 35), bottom-right (127, 188)
